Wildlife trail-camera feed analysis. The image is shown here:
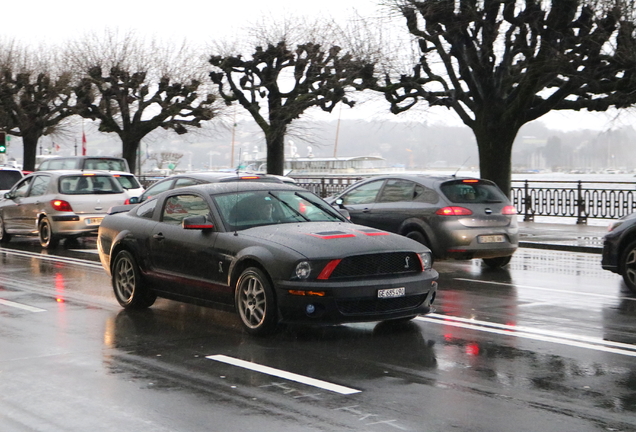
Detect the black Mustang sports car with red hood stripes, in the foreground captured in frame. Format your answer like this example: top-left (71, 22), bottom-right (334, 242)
top-left (98, 182), bottom-right (438, 334)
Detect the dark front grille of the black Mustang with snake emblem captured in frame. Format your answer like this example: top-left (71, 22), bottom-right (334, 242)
top-left (329, 252), bottom-right (422, 279)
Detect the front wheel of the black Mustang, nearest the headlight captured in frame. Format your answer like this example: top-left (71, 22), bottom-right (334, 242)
top-left (235, 267), bottom-right (277, 336)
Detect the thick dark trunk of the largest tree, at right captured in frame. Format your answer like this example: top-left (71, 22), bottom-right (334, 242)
top-left (473, 120), bottom-right (519, 196)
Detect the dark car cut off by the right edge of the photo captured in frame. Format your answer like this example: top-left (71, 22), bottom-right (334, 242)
top-left (601, 213), bottom-right (636, 294)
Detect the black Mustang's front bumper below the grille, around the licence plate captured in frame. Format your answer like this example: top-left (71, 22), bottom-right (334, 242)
top-left (276, 270), bottom-right (438, 324)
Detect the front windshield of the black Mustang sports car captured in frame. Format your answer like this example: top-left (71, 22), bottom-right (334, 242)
top-left (212, 191), bottom-right (346, 230)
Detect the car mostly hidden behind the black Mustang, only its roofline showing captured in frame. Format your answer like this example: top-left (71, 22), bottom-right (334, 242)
top-left (130, 171), bottom-right (283, 204)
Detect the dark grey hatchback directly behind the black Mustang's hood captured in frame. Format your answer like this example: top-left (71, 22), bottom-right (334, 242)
top-left (327, 174), bottom-right (519, 268)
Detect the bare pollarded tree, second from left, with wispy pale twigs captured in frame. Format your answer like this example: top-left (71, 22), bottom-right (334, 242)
top-left (67, 31), bottom-right (216, 172)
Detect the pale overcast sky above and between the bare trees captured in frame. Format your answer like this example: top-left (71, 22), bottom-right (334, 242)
top-left (0, 0), bottom-right (636, 130)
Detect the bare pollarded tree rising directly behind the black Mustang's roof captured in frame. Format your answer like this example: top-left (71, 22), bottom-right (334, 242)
top-left (210, 20), bottom-right (374, 174)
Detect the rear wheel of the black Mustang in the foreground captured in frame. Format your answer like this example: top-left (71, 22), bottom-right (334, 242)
top-left (112, 250), bottom-right (157, 309)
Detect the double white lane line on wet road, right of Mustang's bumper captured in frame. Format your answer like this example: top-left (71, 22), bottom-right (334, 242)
top-left (415, 315), bottom-right (636, 357)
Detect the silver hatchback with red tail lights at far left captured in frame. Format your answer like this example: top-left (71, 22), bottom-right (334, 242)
top-left (0, 170), bottom-right (127, 248)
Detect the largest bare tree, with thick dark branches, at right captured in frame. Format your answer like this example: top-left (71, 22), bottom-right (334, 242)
top-left (380, 0), bottom-right (636, 192)
